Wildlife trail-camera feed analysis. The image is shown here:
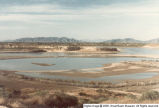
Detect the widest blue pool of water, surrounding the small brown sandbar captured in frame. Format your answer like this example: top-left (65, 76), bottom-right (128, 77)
top-left (0, 57), bottom-right (153, 71)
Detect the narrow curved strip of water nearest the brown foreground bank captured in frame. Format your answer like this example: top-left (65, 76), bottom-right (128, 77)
top-left (16, 72), bottom-right (158, 83)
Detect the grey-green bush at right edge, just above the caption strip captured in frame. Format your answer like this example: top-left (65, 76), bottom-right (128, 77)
top-left (141, 91), bottom-right (159, 100)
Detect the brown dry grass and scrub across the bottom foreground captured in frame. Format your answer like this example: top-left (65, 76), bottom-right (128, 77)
top-left (0, 88), bottom-right (159, 108)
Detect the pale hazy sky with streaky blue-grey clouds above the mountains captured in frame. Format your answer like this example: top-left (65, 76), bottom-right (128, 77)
top-left (0, 0), bottom-right (159, 40)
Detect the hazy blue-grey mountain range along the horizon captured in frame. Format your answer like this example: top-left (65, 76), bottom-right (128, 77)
top-left (2, 37), bottom-right (159, 43)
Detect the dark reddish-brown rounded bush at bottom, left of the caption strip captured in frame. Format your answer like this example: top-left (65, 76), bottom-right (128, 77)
top-left (44, 93), bottom-right (78, 108)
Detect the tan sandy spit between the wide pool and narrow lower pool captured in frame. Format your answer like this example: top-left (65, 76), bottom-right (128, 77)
top-left (12, 60), bottom-right (159, 78)
